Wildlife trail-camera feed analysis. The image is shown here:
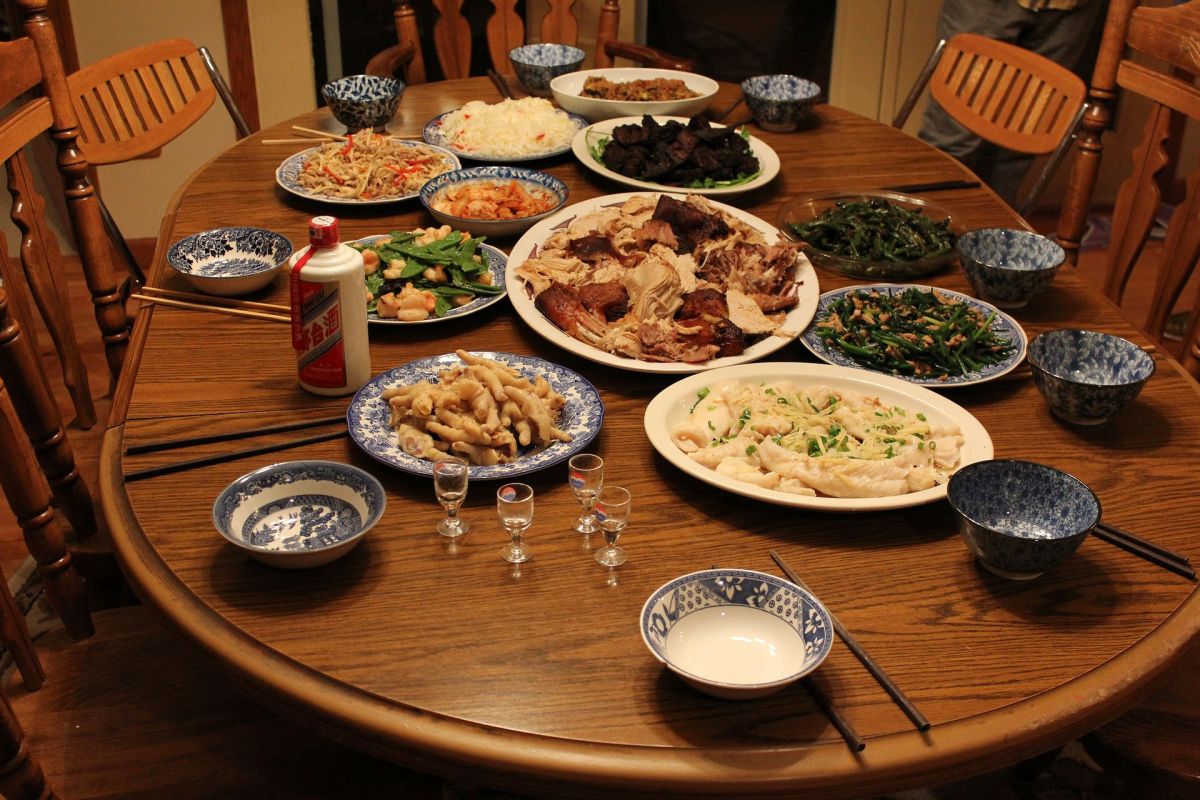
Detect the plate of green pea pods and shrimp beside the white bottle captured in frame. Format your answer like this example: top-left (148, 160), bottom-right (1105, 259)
top-left (348, 228), bottom-right (508, 325)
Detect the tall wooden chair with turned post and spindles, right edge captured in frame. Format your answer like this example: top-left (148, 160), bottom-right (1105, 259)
top-left (1058, 0), bottom-right (1200, 377)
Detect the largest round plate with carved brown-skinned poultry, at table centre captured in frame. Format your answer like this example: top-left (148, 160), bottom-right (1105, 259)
top-left (505, 192), bottom-right (820, 373)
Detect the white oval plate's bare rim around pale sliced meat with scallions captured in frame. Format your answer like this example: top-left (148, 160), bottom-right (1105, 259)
top-left (644, 361), bottom-right (994, 511)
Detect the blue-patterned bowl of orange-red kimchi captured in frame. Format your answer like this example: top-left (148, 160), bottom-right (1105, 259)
top-left (420, 166), bottom-right (568, 237)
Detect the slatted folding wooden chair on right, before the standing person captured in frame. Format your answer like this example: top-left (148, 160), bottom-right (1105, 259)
top-left (892, 34), bottom-right (1087, 216)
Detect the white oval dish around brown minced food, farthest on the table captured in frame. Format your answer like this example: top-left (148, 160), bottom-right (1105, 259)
top-left (550, 67), bottom-right (720, 122)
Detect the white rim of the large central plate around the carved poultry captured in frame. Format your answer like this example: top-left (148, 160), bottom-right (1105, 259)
top-left (504, 192), bottom-right (821, 374)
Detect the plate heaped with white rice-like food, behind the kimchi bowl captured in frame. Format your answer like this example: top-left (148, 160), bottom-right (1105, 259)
top-left (422, 97), bottom-right (588, 163)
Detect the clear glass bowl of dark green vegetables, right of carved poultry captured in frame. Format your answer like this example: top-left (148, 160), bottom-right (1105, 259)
top-left (779, 192), bottom-right (964, 279)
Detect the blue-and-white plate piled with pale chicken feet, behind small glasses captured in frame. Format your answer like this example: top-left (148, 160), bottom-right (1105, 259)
top-left (346, 350), bottom-right (604, 480)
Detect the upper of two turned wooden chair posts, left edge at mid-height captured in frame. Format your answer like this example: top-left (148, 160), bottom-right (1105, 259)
top-left (0, 289), bottom-right (96, 539)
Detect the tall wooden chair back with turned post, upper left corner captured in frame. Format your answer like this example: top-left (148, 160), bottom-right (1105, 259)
top-left (0, 0), bottom-right (130, 388)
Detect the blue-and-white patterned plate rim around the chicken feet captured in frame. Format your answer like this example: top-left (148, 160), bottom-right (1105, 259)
top-left (346, 351), bottom-right (604, 481)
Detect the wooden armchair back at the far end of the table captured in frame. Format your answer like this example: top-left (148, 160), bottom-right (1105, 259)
top-left (366, 0), bottom-right (695, 84)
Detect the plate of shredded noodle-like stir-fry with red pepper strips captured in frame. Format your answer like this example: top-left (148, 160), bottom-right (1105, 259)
top-left (275, 132), bottom-right (462, 205)
